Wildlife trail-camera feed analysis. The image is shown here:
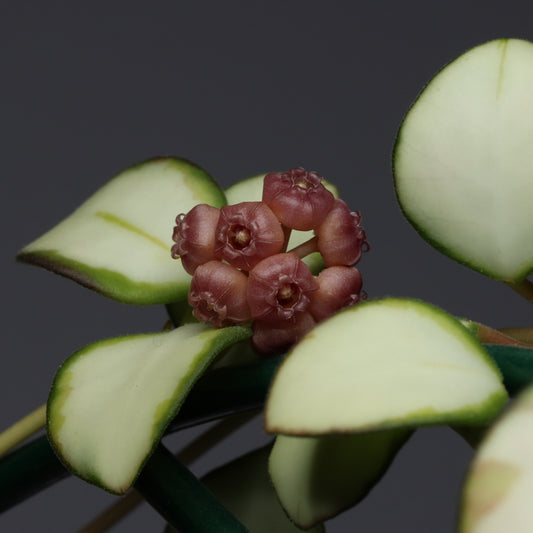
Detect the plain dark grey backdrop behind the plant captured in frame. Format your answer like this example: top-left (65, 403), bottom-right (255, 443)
top-left (0, 0), bottom-right (533, 533)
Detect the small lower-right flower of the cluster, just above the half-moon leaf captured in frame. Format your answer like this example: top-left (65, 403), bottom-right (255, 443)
top-left (309, 266), bottom-right (363, 322)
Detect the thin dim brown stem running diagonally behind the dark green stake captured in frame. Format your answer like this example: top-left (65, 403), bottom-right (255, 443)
top-left (78, 412), bottom-right (257, 533)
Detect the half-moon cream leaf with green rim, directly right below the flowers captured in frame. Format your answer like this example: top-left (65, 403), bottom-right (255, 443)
top-left (266, 298), bottom-right (507, 435)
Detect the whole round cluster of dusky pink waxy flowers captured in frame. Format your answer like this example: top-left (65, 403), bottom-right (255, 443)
top-left (172, 168), bottom-right (368, 353)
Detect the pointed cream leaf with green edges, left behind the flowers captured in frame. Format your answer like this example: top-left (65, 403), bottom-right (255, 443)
top-left (18, 158), bottom-right (225, 304)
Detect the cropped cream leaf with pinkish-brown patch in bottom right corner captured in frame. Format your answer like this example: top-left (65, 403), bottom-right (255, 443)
top-left (459, 387), bottom-right (533, 533)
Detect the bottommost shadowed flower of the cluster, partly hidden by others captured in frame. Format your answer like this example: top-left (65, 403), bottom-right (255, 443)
top-left (252, 313), bottom-right (315, 354)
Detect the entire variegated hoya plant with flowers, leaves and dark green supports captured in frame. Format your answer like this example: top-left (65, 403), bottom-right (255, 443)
top-left (0, 39), bottom-right (533, 533)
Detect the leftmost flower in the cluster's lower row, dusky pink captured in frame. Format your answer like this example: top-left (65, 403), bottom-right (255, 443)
top-left (188, 261), bottom-right (251, 328)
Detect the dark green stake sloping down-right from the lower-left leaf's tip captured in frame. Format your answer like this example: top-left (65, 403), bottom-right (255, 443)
top-left (135, 445), bottom-right (250, 533)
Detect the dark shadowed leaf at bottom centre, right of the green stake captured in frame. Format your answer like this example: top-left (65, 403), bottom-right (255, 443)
top-left (166, 446), bottom-right (324, 533)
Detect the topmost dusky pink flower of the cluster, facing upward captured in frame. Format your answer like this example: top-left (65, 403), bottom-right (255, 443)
top-left (263, 167), bottom-right (334, 231)
